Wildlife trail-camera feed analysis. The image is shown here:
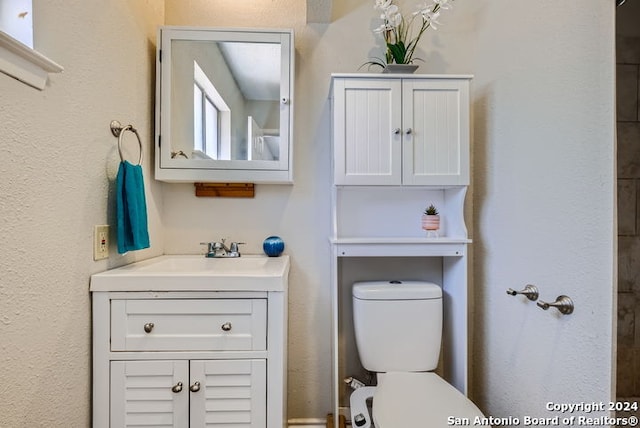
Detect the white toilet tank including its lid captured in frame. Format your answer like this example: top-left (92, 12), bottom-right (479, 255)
top-left (353, 281), bottom-right (442, 372)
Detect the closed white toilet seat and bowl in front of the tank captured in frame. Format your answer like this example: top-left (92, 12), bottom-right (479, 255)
top-left (373, 372), bottom-right (484, 428)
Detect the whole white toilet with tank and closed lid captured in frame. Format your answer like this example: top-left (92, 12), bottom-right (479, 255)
top-left (350, 281), bottom-right (484, 428)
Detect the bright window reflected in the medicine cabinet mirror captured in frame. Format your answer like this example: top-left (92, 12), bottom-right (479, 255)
top-left (193, 61), bottom-right (231, 159)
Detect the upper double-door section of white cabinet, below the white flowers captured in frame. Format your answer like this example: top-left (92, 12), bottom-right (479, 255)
top-left (333, 74), bottom-right (470, 186)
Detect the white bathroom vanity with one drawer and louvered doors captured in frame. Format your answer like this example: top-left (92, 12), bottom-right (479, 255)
top-left (91, 257), bottom-right (288, 428)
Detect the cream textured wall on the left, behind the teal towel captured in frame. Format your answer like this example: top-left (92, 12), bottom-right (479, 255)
top-left (0, 0), bottom-right (163, 428)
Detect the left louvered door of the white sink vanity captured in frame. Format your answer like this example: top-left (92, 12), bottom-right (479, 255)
top-left (111, 360), bottom-right (189, 428)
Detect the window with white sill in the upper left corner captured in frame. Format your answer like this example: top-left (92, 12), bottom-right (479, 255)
top-left (0, 0), bottom-right (63, 90)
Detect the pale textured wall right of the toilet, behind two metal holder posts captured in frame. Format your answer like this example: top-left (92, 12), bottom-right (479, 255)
top-left (470, 0), bottom-right (616, 416)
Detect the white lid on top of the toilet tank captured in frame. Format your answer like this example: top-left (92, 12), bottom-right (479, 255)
top-left (352, 281), bottom-right (442, 300)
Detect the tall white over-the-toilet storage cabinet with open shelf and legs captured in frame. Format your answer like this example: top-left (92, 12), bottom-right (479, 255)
top-left (330, 74), bottom-right (471, 428)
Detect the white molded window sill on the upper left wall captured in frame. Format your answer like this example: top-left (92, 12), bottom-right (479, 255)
top-left (0, 31), bottom-right (64, 90)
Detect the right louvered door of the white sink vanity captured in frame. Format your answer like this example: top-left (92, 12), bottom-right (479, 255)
top-left (189, 359), bottom-right (267, 428)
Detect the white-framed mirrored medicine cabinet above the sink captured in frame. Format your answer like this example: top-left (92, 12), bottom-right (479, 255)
top-left (156, 27), bottom-right (293, 183)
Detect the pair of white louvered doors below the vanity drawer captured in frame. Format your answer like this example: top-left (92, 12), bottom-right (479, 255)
top-left (111, 360), bottom-right (267, 428)
